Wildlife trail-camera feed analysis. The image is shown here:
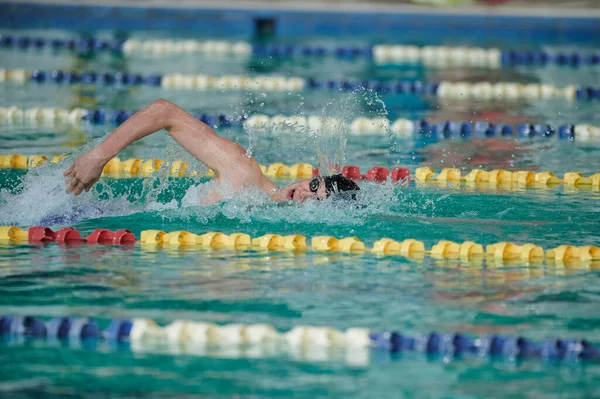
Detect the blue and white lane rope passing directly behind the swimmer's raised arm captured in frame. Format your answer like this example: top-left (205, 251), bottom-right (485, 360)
top-left (0, 106), bottom-right (600, 141)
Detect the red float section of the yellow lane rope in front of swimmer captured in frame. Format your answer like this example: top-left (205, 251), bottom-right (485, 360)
top-left (28, 226), bottom-right (136, 245)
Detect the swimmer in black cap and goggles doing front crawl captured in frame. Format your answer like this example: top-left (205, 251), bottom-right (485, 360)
top-left (64, 99), bottom-right (359, 203)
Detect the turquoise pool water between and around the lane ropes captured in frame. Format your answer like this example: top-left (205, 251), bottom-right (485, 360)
top-left (0, 28), bottom-right (600, 398)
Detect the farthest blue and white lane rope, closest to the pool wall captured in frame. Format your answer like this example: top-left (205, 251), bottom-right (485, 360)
top-left (0, 34), bottom-right (600, 69)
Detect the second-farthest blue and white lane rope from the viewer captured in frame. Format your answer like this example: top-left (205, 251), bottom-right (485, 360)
top-left (0, 69), bottom-right (600, 101)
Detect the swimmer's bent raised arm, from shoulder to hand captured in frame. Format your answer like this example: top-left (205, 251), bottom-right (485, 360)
top-left (64, 99), bottom-right (253, 195)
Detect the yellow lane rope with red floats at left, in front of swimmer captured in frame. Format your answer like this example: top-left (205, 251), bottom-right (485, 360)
top-left (0, 226), bottom-right (600, 265)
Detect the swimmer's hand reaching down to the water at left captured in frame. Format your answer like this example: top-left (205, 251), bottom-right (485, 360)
top-left (64, 149), bottom-right (106, 195)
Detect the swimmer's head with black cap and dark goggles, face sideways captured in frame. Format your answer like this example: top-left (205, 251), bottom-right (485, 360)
top-left (279, 174), bottom-right (360, 202)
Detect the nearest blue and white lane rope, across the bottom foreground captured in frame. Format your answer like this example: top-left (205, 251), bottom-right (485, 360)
top-left (0, 316), bottom-right (600, 362)
